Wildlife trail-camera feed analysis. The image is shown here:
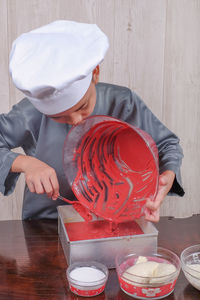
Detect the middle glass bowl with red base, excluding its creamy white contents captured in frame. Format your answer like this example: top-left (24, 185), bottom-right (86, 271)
top-left (115, 247), bottom-right (181, 299)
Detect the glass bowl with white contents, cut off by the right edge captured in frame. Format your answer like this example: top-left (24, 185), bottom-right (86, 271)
top-left (181, 244), bottom-right (200, 290)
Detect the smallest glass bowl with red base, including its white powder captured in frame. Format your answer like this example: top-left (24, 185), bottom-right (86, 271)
top-left (66, 261), bottom-right (108, 297)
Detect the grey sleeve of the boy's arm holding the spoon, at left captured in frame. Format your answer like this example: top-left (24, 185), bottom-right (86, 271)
top-left (0, 99), bottom-right (42, 195)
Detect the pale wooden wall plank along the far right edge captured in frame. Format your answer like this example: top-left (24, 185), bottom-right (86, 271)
top-left (162, 0), bottom-right (200, 217)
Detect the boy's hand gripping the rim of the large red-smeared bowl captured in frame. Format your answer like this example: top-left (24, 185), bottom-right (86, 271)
top-left (145, 170), bottom-right (175, 222)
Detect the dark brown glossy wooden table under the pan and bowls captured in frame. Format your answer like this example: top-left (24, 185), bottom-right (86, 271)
top-left (0, 215), bottom-right (200, 300)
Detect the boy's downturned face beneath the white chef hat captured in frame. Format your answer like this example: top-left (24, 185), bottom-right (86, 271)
top-left (49, 67), bottom-right (99, 125)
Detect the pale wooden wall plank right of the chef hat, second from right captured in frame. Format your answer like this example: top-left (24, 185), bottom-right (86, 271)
top-left (113, 0), bottom-right (166, 118)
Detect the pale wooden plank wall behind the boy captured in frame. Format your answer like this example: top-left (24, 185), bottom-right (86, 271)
top-left (0, 0), bottom-right (200, 220)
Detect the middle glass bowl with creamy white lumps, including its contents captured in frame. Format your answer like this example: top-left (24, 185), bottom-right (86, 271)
top-left (115, 247), bottom-right (181, 299)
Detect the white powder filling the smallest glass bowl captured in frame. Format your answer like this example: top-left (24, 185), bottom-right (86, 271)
top-left (70, 267), bottom-right (105, 283)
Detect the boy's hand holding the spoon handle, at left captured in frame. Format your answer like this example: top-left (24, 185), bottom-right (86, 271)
top-left (11, 155), bottom-right (59, 200)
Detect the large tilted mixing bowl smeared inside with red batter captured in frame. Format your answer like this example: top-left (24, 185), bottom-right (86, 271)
top-left (64, 116), bottom-right (158, 222)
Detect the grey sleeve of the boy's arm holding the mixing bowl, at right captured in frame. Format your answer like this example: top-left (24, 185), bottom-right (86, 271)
top-left (126, 92), bottom-right (184, 196)
